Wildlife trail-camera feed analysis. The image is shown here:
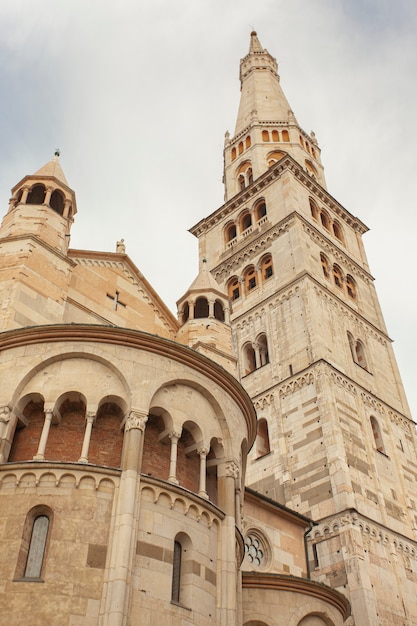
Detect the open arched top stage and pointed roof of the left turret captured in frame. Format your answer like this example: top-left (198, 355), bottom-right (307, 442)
top-left (0, 150), bottom-right (77, 254)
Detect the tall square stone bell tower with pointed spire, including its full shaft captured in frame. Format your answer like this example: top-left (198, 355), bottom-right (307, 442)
top-left (191, 32), bottom-right (417, 626)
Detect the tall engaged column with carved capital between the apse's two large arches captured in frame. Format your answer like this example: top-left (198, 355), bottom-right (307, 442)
top-left (100, 410), bottom-right (148, 626)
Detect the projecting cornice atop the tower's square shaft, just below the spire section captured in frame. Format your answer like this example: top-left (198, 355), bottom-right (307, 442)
top-left (189, 154), bottom-right (368, 237)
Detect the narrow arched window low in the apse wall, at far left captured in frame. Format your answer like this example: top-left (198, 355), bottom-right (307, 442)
top-left (15, 505), bottom-right (52, 581)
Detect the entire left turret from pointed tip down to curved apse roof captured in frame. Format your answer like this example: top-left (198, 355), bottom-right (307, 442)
top-left (0, 151), bottom-right (77, 330)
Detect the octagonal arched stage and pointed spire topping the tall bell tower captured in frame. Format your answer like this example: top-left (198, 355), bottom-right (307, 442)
top-left (224, 31), bottom-right (326, 199)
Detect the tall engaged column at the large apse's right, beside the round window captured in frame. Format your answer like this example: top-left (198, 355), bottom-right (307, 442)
top-left (219, 460), bottom-right (239, 626)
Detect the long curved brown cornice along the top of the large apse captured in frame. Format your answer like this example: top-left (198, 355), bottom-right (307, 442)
top-left (0, 324), bottom-right (256, 448)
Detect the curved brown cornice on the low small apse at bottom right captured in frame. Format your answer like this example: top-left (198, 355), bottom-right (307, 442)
top-left (242, 572), bottom-right (350, 620)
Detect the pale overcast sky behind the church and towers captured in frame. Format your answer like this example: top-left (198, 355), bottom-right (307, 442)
top-left (0, 0), bottom-right (417, 418)
